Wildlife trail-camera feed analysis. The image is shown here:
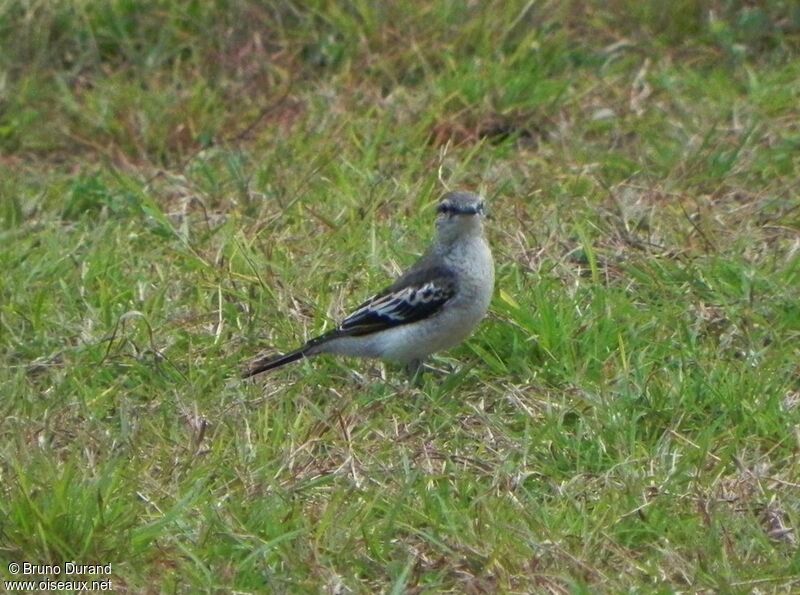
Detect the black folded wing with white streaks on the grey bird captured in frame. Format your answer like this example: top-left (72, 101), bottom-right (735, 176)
top-left (334, 266), bottom-right (456, 336)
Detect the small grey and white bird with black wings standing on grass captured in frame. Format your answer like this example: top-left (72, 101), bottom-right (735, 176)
top-left (242, 192), bottom-right (494, 378)
